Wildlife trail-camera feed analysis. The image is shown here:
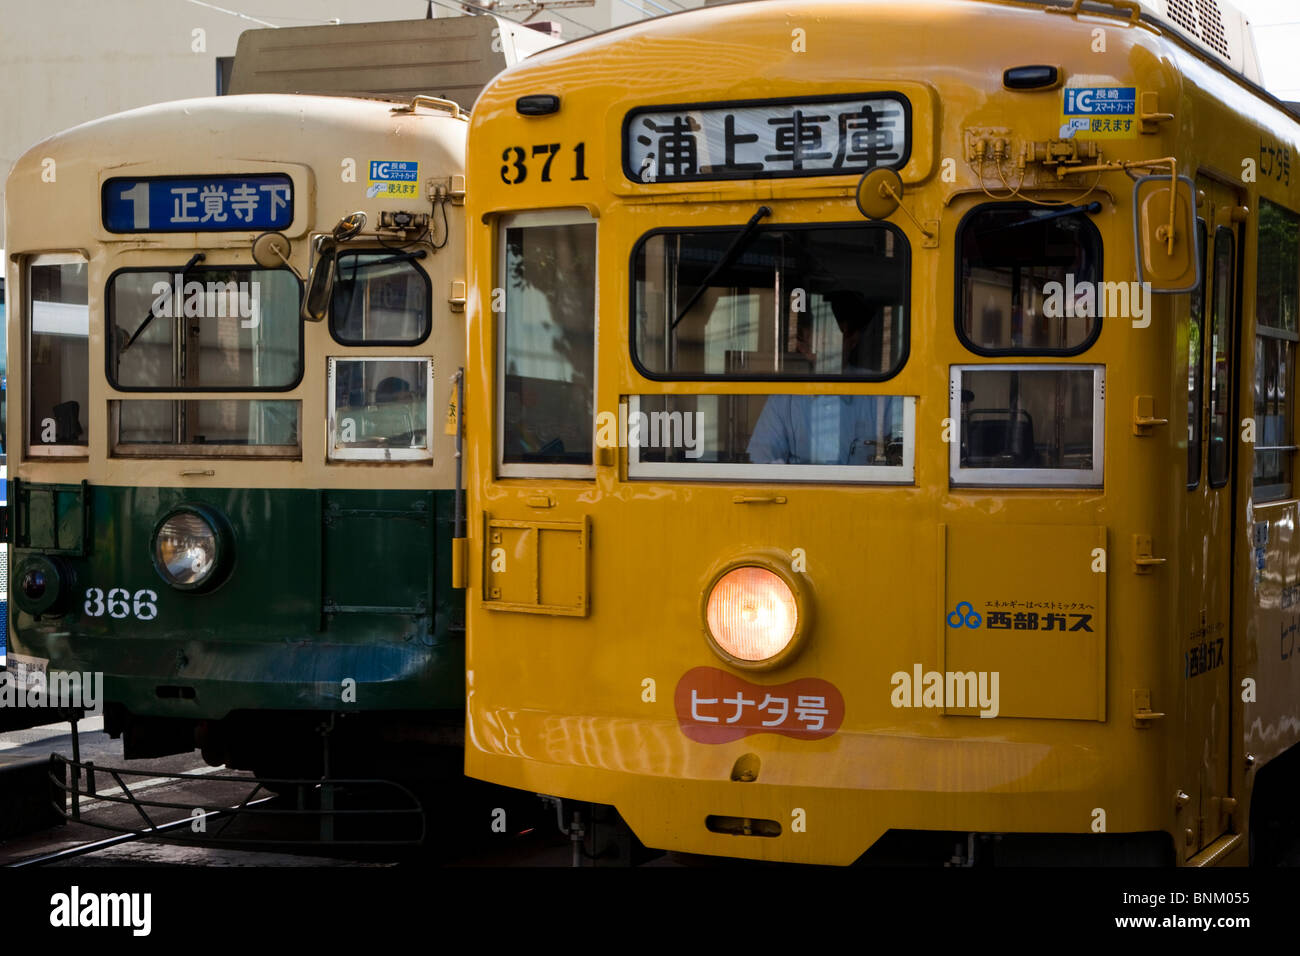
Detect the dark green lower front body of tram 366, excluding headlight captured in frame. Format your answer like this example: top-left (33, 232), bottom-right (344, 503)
top-left (9, 481), bottom-right (464, 721)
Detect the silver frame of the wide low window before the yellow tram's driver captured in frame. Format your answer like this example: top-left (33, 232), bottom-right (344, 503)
top-left (624, 392), bottom-right (917, 485)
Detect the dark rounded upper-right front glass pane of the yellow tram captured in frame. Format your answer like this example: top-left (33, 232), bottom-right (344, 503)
top-left (958, 203), bottom-right (1102, 352)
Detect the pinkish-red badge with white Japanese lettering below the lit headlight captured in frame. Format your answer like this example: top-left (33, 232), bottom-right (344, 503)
top-left (673, 667), bottom-right (844, 744)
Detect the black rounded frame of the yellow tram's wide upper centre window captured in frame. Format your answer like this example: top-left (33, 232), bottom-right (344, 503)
top-left (628, 220), bottom-right (914, 385)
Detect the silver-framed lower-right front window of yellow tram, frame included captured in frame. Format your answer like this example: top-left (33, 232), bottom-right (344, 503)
top-left (950, 365), bottom-right (1105, 488)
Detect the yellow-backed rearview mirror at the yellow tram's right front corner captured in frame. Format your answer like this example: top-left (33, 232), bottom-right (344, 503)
top-left (1134, 176), bottom-right (1201, 293)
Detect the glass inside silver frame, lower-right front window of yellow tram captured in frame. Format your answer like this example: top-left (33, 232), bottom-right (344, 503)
top-left (961, 368), bottom-right (1096, 471)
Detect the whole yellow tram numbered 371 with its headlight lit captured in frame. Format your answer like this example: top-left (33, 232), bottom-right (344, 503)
top-left (465, 0), bottom-right (1300, 865)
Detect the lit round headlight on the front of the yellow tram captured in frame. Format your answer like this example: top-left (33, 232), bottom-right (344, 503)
top-left (706, 566), bottom-right (800, 663)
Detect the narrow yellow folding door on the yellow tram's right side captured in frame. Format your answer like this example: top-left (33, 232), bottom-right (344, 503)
top-left (1170, 178), bottom-right (1242, 858)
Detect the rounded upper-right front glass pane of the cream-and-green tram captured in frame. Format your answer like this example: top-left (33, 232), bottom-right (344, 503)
top-left (330, 250), bottom-right (430, 345)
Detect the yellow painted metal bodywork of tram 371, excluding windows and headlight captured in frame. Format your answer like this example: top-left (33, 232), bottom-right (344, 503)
top-left (465, 0), bottom-right (1300, 864)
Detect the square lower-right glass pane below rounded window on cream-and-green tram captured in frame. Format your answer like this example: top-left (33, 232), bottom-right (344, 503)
top-left (330, 359), bottom-right (429, 457)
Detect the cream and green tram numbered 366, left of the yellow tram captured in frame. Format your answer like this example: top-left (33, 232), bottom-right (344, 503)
top-left (5, 95), bottom-right (467, 777)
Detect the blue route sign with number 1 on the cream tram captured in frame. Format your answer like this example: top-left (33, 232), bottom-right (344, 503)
top-left (103, 173), bottom-right (294, 233)
